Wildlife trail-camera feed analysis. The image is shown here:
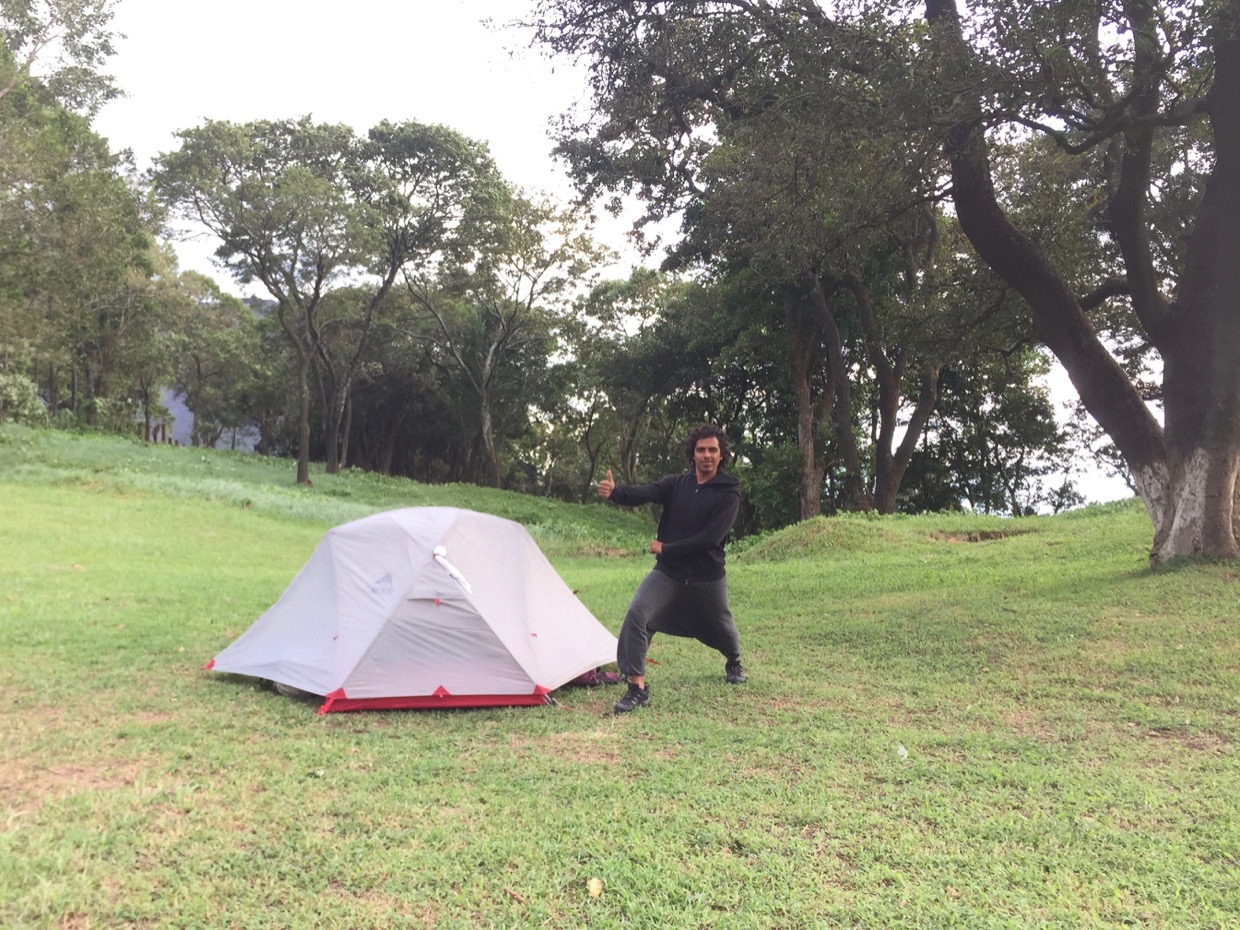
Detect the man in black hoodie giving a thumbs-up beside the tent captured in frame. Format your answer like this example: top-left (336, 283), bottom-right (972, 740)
top-left (599, 424), bottom-right (745, 714)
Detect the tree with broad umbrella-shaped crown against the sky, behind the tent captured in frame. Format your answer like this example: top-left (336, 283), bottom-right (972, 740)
top-left (155, 117), bottom-right (498, 484)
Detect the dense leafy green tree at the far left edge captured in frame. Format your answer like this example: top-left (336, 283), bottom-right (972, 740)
top-left (0, 74), bottom-right (157, 423)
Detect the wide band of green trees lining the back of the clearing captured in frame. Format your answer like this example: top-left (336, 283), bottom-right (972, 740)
top-left (0, 0), bottom-right (1240, 564)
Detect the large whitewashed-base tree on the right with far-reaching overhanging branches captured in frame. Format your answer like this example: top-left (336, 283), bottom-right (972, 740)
top-left (538, 0), bottom-right (1240, 564)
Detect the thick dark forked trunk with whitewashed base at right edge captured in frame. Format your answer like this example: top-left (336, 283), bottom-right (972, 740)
top-left (926, 0), bottom-right (1240, 565)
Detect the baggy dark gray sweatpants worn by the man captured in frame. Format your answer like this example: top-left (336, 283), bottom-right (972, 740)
top-left (616, 572), bottom-right (740, 676)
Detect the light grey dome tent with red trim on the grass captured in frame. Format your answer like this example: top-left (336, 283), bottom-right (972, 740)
top-left (207, 507), bottom-right (616, 713)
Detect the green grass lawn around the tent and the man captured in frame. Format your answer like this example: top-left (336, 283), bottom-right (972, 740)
top-left (0, 428), bottom-right (1240, 930)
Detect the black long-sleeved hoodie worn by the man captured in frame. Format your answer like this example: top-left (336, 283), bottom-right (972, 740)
top-left (609, 470), bottom-right (740, 582)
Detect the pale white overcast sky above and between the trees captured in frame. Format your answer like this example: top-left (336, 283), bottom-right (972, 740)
top-left (84, 0), bottom-right (1131, 501)
